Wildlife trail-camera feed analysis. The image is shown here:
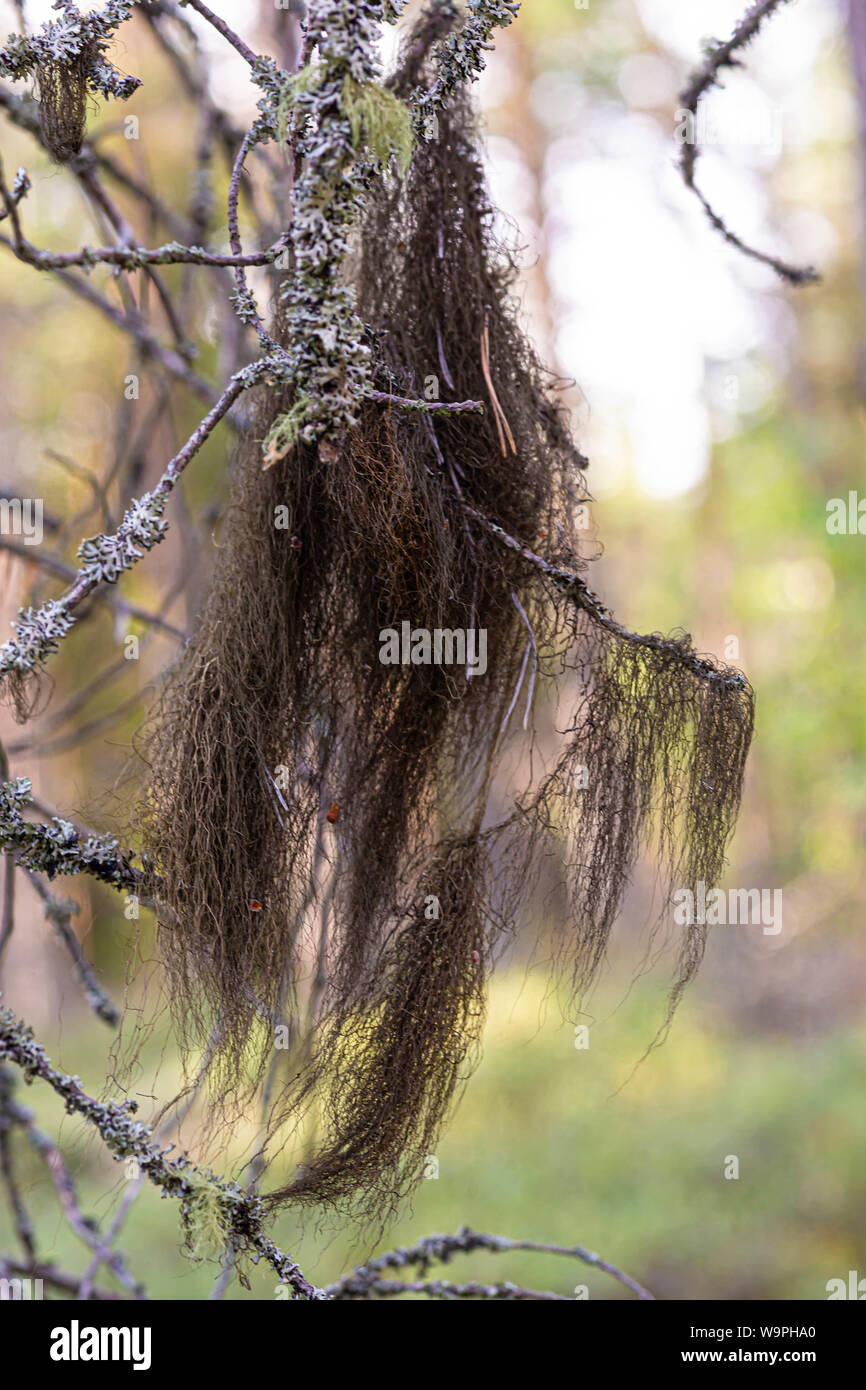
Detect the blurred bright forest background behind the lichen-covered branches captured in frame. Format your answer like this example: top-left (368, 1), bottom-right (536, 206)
top-left (0, 0), bottom-right (866, 1300)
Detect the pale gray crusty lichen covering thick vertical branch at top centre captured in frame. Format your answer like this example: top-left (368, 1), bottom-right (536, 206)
top-left (261, 0), bottom-right (520, 463)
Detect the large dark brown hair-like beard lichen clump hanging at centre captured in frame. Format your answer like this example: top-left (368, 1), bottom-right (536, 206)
top-left (142, 73), bottom-right (752, 1218)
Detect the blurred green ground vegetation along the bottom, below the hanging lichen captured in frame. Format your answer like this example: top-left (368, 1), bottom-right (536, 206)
top-left (0, 966), bottom-right (866, 1301)
